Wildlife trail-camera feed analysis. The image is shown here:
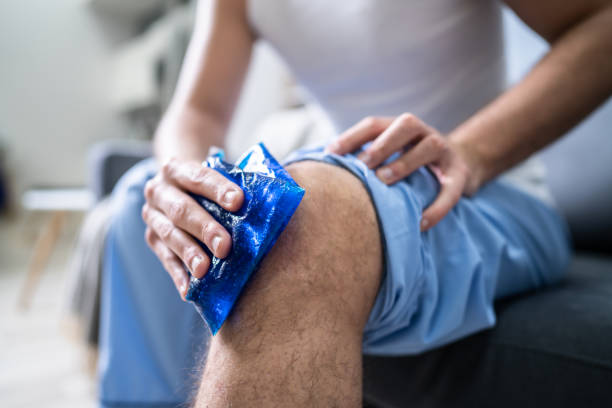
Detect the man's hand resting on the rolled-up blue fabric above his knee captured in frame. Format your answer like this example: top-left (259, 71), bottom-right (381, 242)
top-left (327, 113), bottom-right (477, 231)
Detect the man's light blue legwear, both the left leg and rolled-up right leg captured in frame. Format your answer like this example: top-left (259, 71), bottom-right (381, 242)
top-left (99, 148), bottom-right (570, 406)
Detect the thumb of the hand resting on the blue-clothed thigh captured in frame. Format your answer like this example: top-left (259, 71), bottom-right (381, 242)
top-left (421, 166), bottom-right (465, 231)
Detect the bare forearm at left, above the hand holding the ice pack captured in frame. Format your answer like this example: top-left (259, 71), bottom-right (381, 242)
top-left (154, 0), bottom-right (255, 163)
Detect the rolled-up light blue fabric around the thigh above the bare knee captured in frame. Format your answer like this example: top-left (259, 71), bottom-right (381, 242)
top-left (286, 148), bottom-right (570, 355)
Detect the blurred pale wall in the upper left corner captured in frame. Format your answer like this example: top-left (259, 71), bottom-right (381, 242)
top-left (0, 0), bottom-right (127, 202)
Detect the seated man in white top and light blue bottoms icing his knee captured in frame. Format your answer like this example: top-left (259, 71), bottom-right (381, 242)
top-left (102, 0), bottom-right (612, 407)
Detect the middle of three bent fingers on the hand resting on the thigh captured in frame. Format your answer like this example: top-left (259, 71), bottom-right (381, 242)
top-left (358, 113), bottom-right (430, 169)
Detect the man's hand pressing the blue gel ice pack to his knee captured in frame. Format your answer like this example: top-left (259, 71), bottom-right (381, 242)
top-left (142, 159), bottom-right (244, 298)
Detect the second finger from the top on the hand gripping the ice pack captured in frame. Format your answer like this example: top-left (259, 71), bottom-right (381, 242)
top-left (145, 179), bottom-right (232, 258)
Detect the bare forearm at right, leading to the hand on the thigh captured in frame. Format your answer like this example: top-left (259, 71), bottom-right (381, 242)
top-left (449, 7), bottom-right (612, 189)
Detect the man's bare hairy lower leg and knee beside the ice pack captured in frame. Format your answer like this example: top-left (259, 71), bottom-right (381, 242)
top-left (196, 162), bottom-right (382, 407)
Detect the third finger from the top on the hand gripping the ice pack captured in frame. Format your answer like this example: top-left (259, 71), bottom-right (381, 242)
top-left (142, 204), bottom-right (210, 279)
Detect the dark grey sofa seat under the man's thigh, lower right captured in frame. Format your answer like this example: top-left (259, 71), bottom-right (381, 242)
top-left (364, 256), bottom-right (612, 408)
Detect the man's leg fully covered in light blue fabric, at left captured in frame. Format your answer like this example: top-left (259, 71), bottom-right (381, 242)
top-left (99, 160), bottom-right (208, 406)
